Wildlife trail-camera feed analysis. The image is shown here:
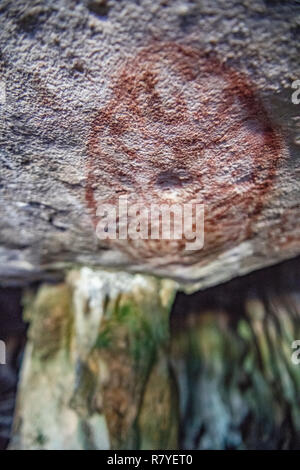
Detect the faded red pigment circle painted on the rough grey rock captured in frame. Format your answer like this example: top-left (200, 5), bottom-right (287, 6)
top-left (85, 43), bottom-right (283, 263)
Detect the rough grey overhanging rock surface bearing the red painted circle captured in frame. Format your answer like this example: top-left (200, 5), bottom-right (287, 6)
top-left (0, 0), bottom-right (300, 289)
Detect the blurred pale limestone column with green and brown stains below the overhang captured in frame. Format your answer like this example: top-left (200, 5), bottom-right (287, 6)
top-left (11, 268), bottom-right (178, 449)
